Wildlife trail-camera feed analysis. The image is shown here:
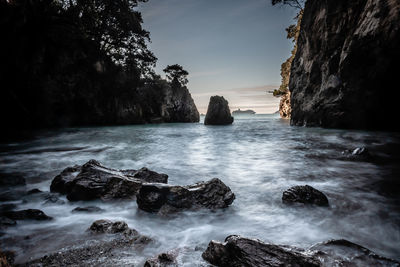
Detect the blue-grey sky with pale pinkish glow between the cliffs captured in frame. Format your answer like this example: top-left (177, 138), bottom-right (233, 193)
top-left (139, 0), bottom-right (296, 113)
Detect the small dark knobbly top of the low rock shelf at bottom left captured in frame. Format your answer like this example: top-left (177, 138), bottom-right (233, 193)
top-left (88, 220), bottom-right (138, 236)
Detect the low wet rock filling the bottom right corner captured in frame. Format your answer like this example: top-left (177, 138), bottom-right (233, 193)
top-left (310, 239), bottom-right (400, 267)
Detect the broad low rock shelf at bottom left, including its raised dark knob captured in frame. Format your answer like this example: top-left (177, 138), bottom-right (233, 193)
top-left (19, 220), bottom-right (152, 267)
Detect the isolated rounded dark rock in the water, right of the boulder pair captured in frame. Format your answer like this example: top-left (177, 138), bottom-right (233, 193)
top-left (282, 185), bottom-right (329, 206)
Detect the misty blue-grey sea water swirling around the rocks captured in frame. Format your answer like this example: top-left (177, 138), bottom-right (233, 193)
top-left (0, 115), bottom-right (400, 266)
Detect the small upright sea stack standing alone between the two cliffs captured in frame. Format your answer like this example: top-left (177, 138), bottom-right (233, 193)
top-left (204, 95), bottom-right (233, 125)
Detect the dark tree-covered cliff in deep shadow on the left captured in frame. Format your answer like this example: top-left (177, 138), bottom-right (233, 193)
top-left (0, 0), bottom-right (198, 141)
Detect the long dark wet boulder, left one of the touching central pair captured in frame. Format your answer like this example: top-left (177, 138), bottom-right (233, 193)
top-left (50, 160), bottom-right (168, 201)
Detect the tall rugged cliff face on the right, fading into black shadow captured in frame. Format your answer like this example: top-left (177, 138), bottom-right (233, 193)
top-left (289, 0), bottom-right (400, 130)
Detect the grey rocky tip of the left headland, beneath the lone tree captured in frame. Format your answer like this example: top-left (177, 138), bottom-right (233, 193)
top-left (161, 86), bottom-right (200, 122)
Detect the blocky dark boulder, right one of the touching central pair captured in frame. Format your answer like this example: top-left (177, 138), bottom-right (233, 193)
top-left (137, 178), bottom-right (235, 214)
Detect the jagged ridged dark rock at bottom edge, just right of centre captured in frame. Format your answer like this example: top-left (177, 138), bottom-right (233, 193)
top-left (202, 236), bottom-right (321, 267)
